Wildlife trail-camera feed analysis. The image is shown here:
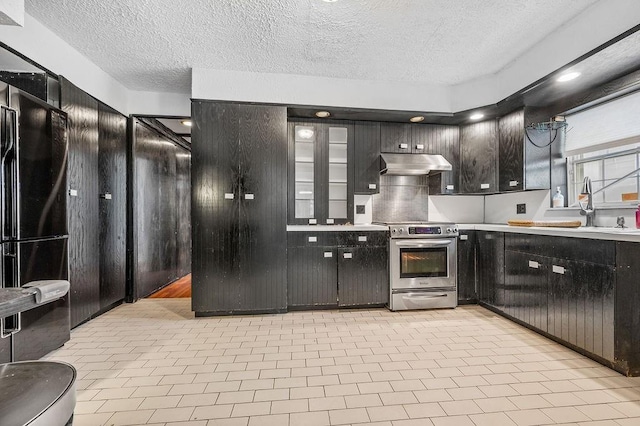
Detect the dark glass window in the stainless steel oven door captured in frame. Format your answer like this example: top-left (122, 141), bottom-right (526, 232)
top-left (400, 247), bottom-right (449, 278)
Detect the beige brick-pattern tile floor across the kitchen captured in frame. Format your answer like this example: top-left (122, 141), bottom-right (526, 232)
top-left (48, 299), bottom-right (640, 426)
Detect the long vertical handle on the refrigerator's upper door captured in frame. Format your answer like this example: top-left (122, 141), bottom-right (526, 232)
top-left (0, 107), bottom-right (18, 240)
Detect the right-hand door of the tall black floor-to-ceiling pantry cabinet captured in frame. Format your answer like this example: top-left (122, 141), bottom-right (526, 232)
top-left (236, 105), bottom-right (287, 311)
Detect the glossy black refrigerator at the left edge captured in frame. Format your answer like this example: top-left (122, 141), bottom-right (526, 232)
top-left (0, 83), bottom-right (70, 362)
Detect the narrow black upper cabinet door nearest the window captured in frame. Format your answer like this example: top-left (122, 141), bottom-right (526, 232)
top-left (498, 110), bottom-right (525, 192)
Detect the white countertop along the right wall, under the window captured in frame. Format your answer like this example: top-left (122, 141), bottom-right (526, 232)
top-left (458, 223), bottom-right (640, 242)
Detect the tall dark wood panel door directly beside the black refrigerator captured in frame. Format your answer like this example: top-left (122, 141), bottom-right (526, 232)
top-left (60, 77), bottom-right (100, 327)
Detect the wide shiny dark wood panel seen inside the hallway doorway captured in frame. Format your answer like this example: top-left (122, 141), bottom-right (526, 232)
top-left (131, 119), bottom-right (178, 299)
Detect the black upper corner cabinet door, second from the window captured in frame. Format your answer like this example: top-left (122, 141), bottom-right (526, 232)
top-left (460, 120), bottom-right (498, 193)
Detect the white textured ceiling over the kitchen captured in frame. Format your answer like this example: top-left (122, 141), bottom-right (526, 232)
top-left (25, 0), bottom-right (597, 93)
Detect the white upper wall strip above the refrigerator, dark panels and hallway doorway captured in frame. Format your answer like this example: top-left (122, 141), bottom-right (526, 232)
top-left (0, 13), bottom-right (191, 115)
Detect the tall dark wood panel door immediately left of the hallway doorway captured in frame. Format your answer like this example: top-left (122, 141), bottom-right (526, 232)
top-left (98, 103), bottom-right (127, 309)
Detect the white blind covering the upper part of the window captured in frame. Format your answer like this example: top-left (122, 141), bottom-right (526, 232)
top-left (565, 91), bottom-right (640, 156)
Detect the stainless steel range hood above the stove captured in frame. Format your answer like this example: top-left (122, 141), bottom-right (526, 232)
top-left (380, 153), bottom-right (452, 176)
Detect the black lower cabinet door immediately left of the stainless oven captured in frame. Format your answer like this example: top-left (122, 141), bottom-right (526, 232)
top-left (338, 247), bottom-right (389, 306)
